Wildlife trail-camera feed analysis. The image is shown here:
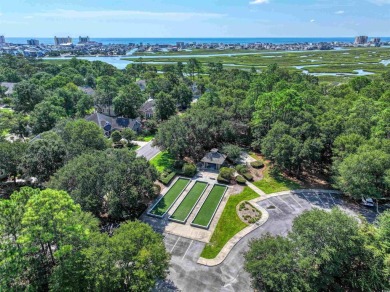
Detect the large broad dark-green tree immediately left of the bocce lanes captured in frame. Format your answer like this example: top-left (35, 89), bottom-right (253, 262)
top-left (48, 149), bottom-right (157, 219)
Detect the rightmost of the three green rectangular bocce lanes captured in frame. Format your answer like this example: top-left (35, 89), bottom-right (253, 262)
top-left (192, 185), bottom-right (226, 227)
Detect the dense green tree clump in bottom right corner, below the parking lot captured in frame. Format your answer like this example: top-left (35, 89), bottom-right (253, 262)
top-left (245, 209), bottom-right (390, 291)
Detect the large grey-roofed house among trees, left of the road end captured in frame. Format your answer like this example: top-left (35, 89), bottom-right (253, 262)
top-left (85, 112), bottom-right (142, 137)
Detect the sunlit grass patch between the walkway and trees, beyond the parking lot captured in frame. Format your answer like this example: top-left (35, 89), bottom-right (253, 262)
top-left (253, 165), bottom-right (301, 194)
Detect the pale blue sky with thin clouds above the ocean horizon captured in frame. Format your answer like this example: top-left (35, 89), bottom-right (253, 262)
top-left (0, 0), bottom-right (390, 38)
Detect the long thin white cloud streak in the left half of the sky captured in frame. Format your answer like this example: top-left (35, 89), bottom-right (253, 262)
top-left (36, 9), bottom-right (226, 20)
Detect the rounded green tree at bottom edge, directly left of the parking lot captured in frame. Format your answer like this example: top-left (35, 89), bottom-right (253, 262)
top-left (84, 221), bottom-right (169, 291)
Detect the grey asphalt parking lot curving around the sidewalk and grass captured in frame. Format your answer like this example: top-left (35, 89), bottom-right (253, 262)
top-left (159, 192), bottom-right (386, 292)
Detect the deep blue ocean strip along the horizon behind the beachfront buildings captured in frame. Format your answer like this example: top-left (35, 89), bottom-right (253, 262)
top-left (6, 37), bottom-right (390, 45)
